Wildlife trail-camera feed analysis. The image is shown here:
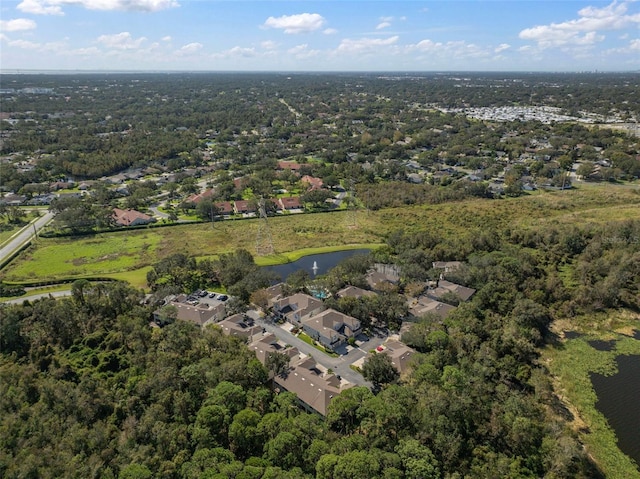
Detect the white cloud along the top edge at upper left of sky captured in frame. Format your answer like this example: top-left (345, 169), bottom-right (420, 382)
top-left (17, 0), bottom-right (180, 15)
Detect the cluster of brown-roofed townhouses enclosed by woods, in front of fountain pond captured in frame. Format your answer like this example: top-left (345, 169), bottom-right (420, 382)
top-left (154, 261), bottom-right (475, 416)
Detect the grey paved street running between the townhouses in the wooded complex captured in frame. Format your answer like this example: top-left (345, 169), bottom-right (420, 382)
top-left (247, 311), bottom-right (382, 387)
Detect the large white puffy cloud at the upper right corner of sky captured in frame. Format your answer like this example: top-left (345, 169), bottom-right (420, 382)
top-left (519, 1), bottom-right (640, 48)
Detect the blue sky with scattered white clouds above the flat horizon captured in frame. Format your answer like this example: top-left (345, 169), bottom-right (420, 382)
top-left (0, 0), bottom-right (640, 71)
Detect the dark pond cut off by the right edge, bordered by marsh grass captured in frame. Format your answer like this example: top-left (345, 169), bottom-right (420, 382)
top-left (591, 356), bottom-right (640, 465)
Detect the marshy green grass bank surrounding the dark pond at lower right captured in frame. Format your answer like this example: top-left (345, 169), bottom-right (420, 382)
top-left (541, 312), bottom-right (640, 479)
